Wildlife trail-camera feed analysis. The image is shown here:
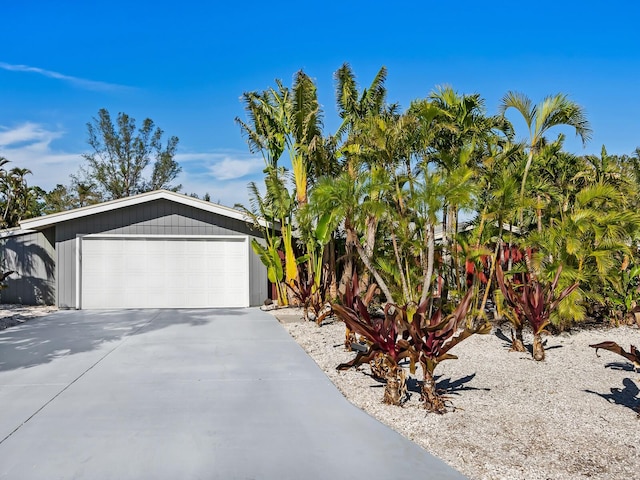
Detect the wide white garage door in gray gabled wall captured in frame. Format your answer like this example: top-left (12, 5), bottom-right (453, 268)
top-left (79, 236), bottom-right (249, 308)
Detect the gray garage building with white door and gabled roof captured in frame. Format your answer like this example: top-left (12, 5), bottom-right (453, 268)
top-left (0, 190), bottom-right (269, 309)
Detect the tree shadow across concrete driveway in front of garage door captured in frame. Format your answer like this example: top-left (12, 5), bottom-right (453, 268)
top-left (0, 309), bottom-right (248, 372)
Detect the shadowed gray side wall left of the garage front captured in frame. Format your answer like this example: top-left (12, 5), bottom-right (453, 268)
top-left (0, 228), bottom-right (56, 305)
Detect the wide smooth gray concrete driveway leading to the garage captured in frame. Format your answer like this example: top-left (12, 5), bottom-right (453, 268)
top-left (0, 309), bottom-right (464, 480)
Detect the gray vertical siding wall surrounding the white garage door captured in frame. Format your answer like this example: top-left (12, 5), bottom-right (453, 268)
top-left (55, 200), bottom-right (268, 308)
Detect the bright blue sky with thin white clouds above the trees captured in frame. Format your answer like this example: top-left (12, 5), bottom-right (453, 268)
top-left (0, 0), bottom-right (640, 205)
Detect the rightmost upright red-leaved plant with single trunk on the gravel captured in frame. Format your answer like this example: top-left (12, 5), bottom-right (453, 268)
top-left (496, 262), bottom-right (578, 361)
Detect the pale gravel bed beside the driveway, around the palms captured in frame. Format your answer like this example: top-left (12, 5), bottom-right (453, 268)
top-left (272, 310), bottom-right (640, 480)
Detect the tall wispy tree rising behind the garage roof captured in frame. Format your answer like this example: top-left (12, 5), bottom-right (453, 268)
top-left (77, 108), bottom-right (181, 200)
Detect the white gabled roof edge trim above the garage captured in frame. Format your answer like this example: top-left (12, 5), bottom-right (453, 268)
top-left (20, 190), bottom-right (266, 230)
